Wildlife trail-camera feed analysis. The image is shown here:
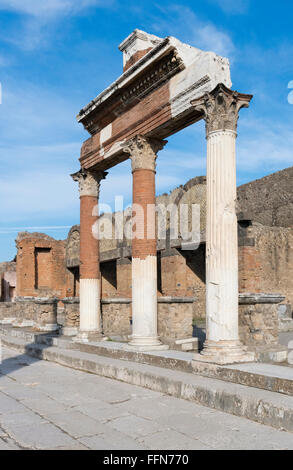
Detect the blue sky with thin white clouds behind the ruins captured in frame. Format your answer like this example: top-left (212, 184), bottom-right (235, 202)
top-left (0, 0), bottom-right (293, 261)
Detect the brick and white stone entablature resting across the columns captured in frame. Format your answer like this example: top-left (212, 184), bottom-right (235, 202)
top-left (77, 33), bottom-right (231, 170)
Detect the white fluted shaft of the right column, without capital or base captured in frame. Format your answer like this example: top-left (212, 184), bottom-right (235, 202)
top-left (206, 130), bottom-right (238, 341)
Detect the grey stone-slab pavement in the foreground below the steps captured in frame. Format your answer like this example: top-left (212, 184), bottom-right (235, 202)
top-left (0, 349), bottom-right (293, 450)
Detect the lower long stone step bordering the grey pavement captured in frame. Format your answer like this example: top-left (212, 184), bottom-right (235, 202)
top-left (2, 337), bottom-right (293, 433)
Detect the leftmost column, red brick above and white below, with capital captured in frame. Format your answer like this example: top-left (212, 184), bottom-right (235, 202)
top-left (72, 170), bottom-right (105, 342)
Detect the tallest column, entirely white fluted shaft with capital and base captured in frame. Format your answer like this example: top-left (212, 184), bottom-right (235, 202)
top-left (192, 84), bottom-right (253, 364)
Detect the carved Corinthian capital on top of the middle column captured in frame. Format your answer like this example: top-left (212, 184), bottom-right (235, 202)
top-left (123, 135), bottom-right (167, 171)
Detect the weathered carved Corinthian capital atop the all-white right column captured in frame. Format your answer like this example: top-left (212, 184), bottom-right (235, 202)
top-left (191, 83), bottom-right (253, 137)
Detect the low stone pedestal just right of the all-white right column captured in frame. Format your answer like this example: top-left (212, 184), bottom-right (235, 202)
top-left (239, 293), bottom-right (284, 349)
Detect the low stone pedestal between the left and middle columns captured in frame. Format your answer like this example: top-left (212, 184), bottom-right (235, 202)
top-left (102, 298), bottom-right (132, 337)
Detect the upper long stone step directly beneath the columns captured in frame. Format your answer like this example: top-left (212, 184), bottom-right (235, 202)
top-left (0, 326), bottom-right (293, 396)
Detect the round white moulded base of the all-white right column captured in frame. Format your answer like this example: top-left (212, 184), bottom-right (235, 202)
top-left (193, 341), bottom-right (255, 365)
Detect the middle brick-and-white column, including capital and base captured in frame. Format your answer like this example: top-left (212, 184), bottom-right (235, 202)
top-left (124, 136), bottom-right (168, 351)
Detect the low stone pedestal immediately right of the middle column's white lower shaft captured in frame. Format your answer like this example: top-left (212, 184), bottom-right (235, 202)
top-left (158, 297), bottom-right (196, 346)
